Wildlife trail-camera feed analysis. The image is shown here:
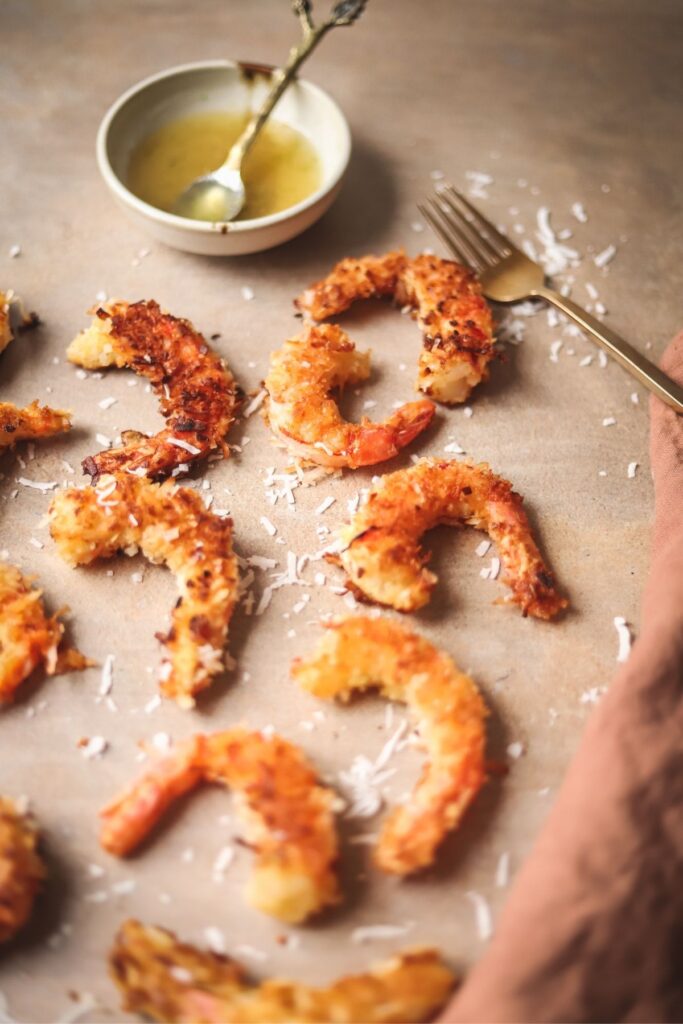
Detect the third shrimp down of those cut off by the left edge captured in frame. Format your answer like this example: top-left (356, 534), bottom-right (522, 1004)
top-left (0, 561), bottom-right (93, 703)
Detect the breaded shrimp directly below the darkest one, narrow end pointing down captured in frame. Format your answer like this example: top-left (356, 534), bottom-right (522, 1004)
top-left (48, 474), bottom-right (238, 708)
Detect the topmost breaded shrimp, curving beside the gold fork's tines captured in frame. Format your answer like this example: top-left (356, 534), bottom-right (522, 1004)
top-left (295, 250), bottom-right (495, 406)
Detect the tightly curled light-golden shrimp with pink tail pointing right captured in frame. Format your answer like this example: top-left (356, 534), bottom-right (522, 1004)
top-left (265, 324), bottom-right (434, 469)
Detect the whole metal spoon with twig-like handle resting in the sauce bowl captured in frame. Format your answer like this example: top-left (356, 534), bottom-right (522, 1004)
top-left (173, 0), bottom-right (367, 222)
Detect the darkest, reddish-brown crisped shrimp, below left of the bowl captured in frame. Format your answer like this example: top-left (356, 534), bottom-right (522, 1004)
top-left (67, 301), bottom-right (240, 478)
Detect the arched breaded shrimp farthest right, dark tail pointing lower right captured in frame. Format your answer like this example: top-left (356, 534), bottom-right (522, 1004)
top-left (331, 459), bottom-right (567, 618)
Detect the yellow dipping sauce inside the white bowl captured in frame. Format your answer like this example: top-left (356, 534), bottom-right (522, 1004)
top-left (126, 112), bottom-right (322, 220)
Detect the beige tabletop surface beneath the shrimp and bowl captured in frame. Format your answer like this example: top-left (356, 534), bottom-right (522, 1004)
top-left (0, 0), bottom-right (683, 1021)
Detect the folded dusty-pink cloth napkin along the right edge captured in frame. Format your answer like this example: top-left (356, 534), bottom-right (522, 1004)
top-left (441, 333), bottom-right (683, 1024)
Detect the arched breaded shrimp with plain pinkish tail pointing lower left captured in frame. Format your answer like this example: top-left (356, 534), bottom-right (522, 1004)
top-left (100, 728), bottom-right (339, 924)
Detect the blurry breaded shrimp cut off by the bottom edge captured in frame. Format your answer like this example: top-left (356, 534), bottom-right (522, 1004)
top-left (110, 921), bottom-right (456, 1024)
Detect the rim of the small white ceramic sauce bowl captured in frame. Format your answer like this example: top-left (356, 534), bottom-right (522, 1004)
top-left (95, 58), bottom-right (351, 234)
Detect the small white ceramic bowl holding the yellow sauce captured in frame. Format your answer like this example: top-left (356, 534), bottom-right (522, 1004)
top-left (97, 60), bottom-right (351, 256)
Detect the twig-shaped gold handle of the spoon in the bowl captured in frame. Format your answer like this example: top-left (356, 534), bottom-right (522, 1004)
top-left (223, 0), bottom-right (366, 171)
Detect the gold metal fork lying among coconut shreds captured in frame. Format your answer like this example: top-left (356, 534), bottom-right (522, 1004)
top-left (418, 185), bottom-right (683, 413)
